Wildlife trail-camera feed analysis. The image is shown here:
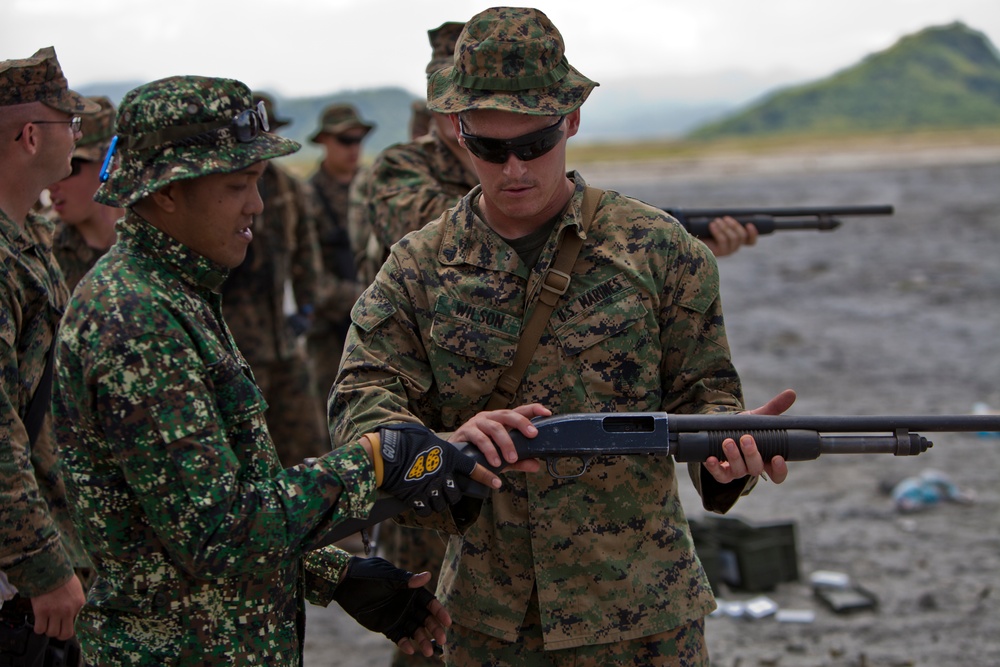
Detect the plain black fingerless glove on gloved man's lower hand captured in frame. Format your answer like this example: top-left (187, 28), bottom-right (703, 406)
top-left (333, 556), bottom-right (434, 643)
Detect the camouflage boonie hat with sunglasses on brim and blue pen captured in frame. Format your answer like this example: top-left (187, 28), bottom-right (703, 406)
top-left (94, 76), bottom-right (301, 208)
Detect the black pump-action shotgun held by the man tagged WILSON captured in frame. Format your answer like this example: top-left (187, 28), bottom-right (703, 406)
top-left (329, 412), bottom-right (1000, 542)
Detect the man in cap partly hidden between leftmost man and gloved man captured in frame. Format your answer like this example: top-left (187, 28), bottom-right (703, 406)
top-left (49, 96), bottom-right (122, 292)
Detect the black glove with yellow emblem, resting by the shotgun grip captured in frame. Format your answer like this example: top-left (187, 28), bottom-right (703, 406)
top-left (369, 424), bottom-right (476, 516)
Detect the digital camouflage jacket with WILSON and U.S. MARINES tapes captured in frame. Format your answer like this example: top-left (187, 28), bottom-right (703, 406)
top-left (330, 175), bottom-right (743, 649)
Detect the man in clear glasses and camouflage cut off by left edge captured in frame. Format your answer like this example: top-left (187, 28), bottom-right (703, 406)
top-left (0, 47), bottom-right (98, 640)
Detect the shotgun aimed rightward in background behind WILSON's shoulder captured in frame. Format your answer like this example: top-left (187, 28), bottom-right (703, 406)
top-left (663, 205), bottom-right (893, 239)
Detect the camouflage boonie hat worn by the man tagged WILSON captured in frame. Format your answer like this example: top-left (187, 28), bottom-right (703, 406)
top-left (427, 7), bottom-right (598, 116)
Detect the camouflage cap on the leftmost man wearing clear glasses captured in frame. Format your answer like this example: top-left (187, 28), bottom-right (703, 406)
top-left (0, 46), bottom-right (100, 114)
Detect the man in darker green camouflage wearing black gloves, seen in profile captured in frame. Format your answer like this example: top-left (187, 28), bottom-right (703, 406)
top-left (54, 77), bottom-right (499, 666)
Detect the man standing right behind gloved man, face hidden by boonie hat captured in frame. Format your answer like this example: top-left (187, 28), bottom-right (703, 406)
top-left (222, 93), bottom-right (330, 468)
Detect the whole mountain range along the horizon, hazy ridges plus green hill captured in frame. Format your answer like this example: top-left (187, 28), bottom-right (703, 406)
top-left (77, 23), bottom-right (1000, 153)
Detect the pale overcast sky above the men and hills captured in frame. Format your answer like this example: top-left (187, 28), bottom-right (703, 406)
top-left (7, 0), bottom-right (1000, 96)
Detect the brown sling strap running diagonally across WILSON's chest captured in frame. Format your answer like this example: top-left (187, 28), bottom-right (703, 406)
top-left (486, 187), bottom-right (604, 410)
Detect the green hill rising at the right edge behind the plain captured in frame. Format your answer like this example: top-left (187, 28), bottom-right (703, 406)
top-left (688, 23), bottom-right (1000, 139)
